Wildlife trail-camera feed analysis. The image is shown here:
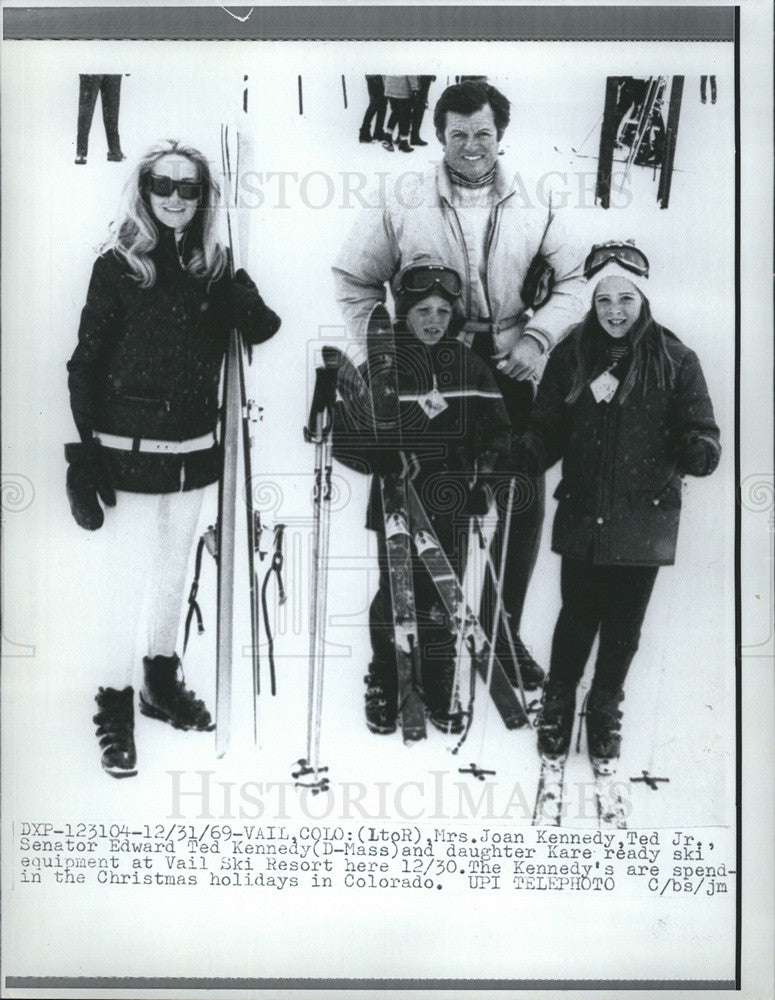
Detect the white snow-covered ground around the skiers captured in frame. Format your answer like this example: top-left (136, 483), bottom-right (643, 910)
top-left (2, 37), bottom-right (735, 960)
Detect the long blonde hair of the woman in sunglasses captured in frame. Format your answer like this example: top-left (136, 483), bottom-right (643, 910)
top-left (100, 139), bottom-right (227, 288)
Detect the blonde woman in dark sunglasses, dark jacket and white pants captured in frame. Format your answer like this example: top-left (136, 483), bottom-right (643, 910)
top-left (65, 141), bottom-right (280, 777)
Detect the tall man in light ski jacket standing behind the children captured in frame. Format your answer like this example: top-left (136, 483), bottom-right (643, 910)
top-left (333, 81), bottom-right (585, 688)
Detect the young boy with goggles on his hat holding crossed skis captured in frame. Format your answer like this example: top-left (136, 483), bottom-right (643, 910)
top-left (334, 259), bottom-right (510, 734)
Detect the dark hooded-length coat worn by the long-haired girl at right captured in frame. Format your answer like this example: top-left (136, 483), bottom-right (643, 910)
top-left (522, 327), bottom-right (721, 566)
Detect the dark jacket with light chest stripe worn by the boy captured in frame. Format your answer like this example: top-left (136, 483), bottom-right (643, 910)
top-left (334, 322), bottom-right (510, 531)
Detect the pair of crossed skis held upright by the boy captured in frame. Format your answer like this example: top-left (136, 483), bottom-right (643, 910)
top-left (325, 305), bottom-right (527, 743)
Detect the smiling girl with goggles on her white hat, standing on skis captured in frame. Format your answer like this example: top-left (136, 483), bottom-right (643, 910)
top-left (513, 242), bottom-right (721, 768)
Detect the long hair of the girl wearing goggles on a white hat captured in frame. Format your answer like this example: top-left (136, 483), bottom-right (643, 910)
top-left (565, 292), bottom-right (675, 404)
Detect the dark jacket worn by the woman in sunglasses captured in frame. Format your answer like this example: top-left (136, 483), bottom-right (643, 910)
top-left (67, 227), bottom-right (280, 493)
